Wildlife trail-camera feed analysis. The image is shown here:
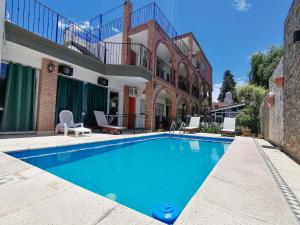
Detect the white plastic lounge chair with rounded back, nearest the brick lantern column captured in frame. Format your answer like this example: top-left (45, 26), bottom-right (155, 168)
top-left (55, 110), bottom-right (92, 137)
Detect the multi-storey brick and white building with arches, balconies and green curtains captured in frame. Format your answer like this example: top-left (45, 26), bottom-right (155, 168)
top-left (0, 0), bottom-right (212, 132)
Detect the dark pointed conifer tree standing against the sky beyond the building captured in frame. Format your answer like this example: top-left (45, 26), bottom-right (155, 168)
top-left (218, 70), bottom-right (237, 102)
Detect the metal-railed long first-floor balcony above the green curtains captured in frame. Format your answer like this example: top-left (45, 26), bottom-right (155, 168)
top-left (6, 0), bottom-right (150, 69)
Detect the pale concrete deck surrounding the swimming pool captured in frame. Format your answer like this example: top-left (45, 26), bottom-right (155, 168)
top-left (0, 133), bottom-right (300, 225)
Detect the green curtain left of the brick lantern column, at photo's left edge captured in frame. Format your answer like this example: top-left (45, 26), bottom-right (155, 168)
top-left (1, 63), bottom-right (36, 131)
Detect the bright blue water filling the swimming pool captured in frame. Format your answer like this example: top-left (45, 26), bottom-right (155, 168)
top-left (10, 136), bottom-right (229, 220)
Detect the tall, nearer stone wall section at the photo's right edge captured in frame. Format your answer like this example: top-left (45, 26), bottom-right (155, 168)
top-left (283, 0), bottom-right (300, 162)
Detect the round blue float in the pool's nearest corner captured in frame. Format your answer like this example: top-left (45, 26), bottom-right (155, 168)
top-left (152, 204), bottom-right (179, 224)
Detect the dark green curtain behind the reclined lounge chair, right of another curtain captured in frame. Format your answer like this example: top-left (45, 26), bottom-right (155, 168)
top-left (85, 84), bottom-right (108, 127)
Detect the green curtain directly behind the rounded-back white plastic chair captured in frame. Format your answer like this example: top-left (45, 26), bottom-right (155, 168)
top-left (56, 76), bottom-right (83, 123)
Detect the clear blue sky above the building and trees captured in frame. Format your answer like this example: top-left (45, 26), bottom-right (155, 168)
top-left (41, 0), bottom-right (292, 98)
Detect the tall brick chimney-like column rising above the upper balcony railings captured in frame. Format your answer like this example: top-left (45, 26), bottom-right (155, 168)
top-left (122, 0), bottom-right (132, 64)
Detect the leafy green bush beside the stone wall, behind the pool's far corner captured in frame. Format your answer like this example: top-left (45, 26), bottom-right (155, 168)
top-left (238, 85), bottom-right (267, 134)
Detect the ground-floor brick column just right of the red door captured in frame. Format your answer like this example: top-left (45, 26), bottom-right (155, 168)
top-left (145, 82), bottom-right (155, 130)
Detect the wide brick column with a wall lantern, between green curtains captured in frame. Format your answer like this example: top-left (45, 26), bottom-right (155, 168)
top-left (36, 58), bottom-right (58, 133)
